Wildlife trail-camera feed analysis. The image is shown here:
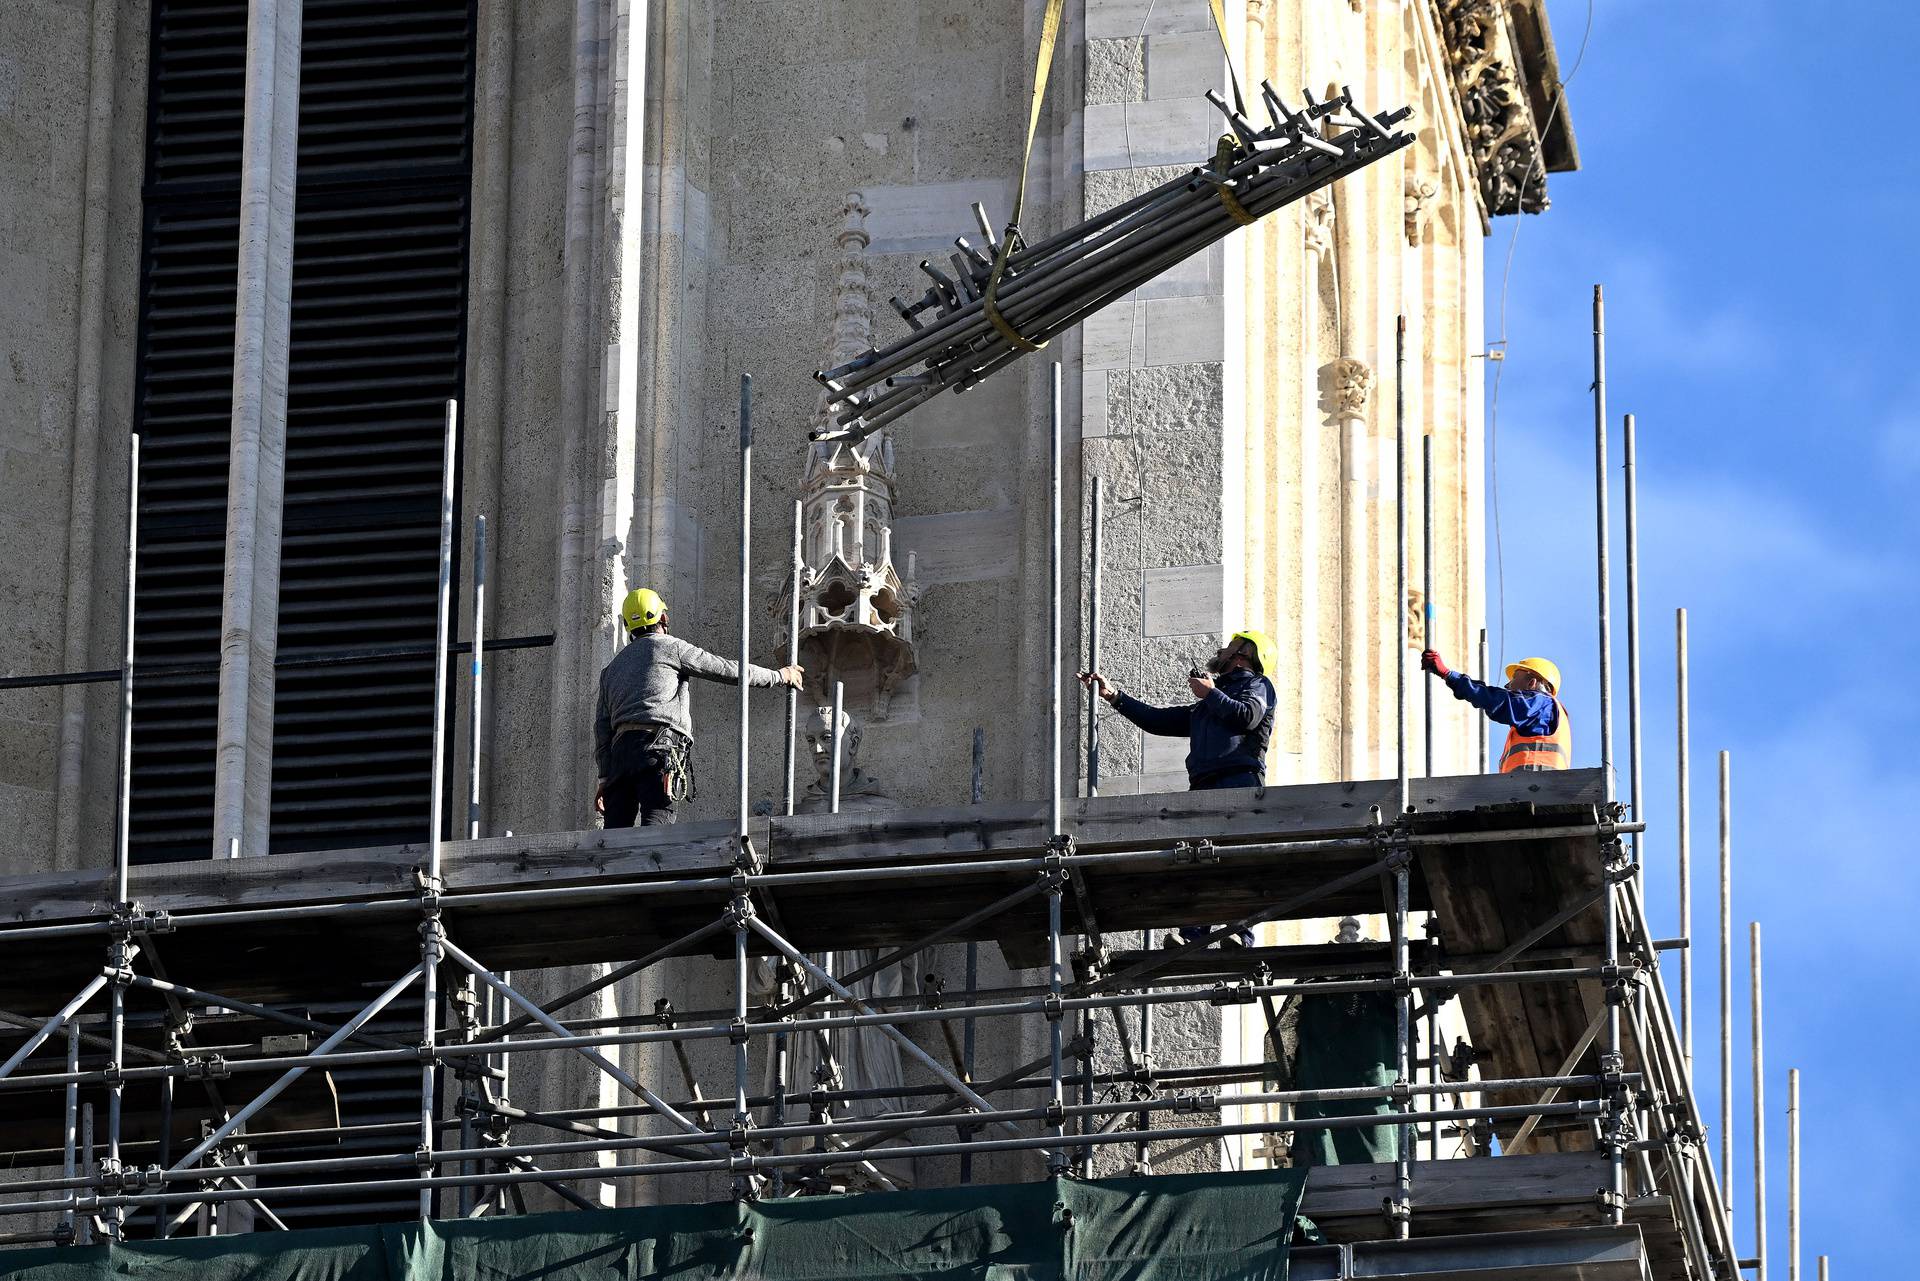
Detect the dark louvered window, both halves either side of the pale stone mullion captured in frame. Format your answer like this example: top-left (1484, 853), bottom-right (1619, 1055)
top-left (132, 0), bottom-right (474, 862)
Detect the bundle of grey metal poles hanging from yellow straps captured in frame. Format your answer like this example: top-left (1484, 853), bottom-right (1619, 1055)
top-left (814, 83), bottom-right (1413, 440)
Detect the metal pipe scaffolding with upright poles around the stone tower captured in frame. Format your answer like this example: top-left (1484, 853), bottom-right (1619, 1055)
top-left (0, 318), bottom-right (1797, 1279)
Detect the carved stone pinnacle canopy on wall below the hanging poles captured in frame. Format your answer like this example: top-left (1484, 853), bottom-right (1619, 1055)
top-left (801, 192), bottom-right (918, 720)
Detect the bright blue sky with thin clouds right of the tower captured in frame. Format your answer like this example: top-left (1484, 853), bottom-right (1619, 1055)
top-left (1486, 0), bottom-right (1920, 1279)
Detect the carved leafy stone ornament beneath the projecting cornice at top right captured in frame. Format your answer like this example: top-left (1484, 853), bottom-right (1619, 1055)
top-left (1434, 0), bottom-right (1548, 213)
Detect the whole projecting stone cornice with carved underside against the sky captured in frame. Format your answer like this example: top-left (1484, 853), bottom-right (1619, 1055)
top-left (1428, 0), bottom-right (1580, 215)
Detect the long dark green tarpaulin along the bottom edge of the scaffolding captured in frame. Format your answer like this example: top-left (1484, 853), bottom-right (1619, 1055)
top-left (0, 1170), bottom-right (1306, 1281)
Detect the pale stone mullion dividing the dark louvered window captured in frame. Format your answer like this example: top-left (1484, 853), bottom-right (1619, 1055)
top-left (213, 0), bottom-right (301, 858)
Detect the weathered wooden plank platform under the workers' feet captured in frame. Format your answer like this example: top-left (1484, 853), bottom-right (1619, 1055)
top-left (0, 770), bottom-right (1599, 998)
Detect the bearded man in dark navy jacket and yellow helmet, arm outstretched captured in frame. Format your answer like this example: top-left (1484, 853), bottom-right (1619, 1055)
top-left (1079, 630), bottom-right (1277, 947)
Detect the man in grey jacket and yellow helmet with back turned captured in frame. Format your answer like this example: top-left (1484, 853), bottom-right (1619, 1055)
top-left (593, 588), bottom-right (804, 828)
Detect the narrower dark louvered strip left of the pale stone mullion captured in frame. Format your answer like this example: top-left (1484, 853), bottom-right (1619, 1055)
top-left (132, 0), bottom-right (246, 862)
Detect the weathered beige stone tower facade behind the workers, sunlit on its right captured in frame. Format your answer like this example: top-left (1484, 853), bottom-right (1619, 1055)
top-left (0, 0), bottom-right (1572, 1196)
